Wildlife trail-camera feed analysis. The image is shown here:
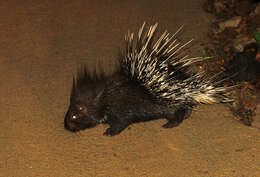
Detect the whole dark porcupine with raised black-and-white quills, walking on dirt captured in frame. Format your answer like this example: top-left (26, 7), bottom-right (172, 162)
top-left (64, 23), bottom-right (232, 136)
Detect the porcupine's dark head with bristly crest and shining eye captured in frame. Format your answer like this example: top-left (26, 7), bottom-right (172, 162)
top-left (64, 70), bottom-right (105, 132)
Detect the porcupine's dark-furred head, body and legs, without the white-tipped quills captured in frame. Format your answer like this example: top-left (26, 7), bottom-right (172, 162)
top-left (64, 69), bottom-right (191, 136)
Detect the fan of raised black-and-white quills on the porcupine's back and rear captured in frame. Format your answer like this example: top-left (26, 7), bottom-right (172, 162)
top-left (120, 22), bottom-right (230, 104)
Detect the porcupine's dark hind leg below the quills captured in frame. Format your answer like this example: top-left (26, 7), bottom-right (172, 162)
top-left (162, 108), bottom-right (192, 128)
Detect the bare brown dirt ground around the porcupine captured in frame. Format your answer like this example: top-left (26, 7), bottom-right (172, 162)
top-left (0, 0), bottom-right (260, 177)
